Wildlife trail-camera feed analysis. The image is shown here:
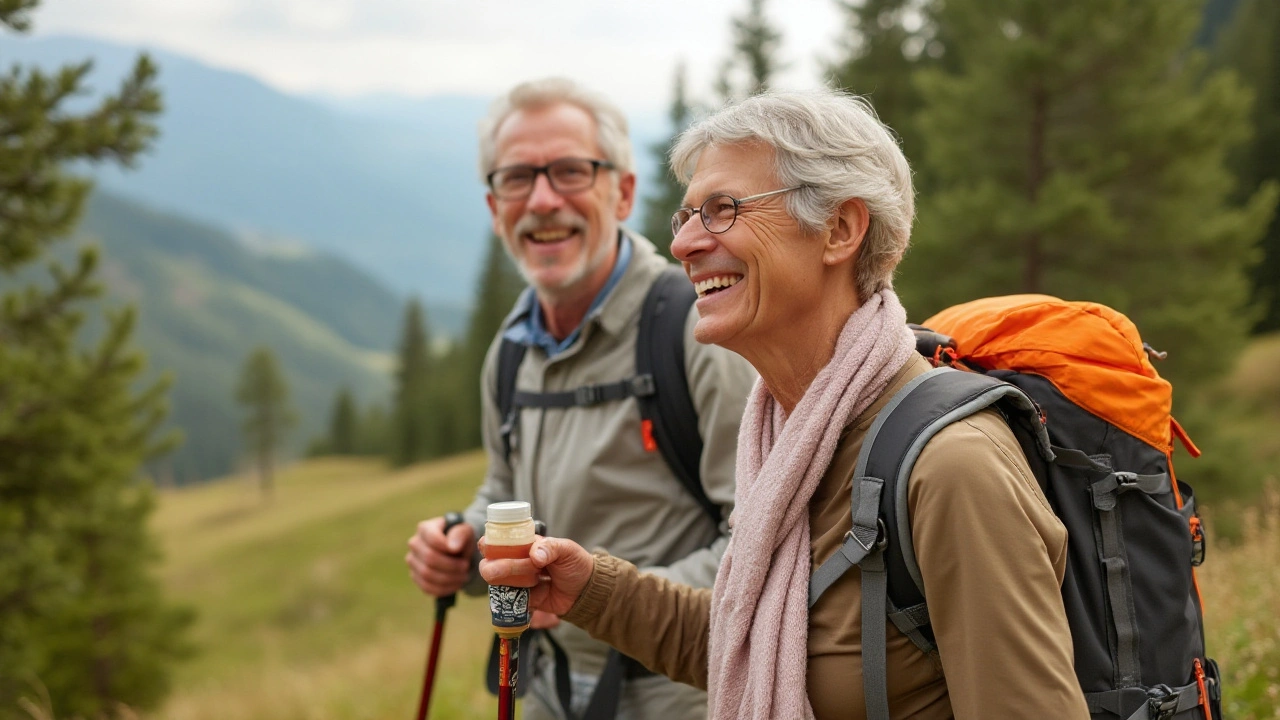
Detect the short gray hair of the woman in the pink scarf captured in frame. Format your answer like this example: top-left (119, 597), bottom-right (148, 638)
top-left (671, 90), bottom-right (915, 302)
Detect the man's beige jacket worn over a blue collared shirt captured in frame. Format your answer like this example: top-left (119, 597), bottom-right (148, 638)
top-left (465, 233), bottom-right (755, 675)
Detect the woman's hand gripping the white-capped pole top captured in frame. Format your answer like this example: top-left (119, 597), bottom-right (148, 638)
top-left (480, 538), bottom-right (595, 615)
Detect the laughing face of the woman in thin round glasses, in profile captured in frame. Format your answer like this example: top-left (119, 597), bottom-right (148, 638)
top-left (671, 142), bottom-right (824, 352)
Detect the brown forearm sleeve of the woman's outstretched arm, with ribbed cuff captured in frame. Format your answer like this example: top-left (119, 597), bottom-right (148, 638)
top-left (564, 550), bottom-right (712, 691)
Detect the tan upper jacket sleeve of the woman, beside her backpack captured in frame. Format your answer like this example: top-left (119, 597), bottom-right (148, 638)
top-left (909, 411), bottom-right (1089, 720)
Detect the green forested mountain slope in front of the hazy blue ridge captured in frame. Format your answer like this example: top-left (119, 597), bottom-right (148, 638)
top-left (79, 192), bottom-right (403, 482)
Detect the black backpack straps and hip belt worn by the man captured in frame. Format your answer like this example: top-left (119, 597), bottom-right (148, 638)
top-left (486, 266), bottom-right (721, 720)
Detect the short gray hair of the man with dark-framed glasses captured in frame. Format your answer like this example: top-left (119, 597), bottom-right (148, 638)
top-left (480, 77), bottom-right (635, 178)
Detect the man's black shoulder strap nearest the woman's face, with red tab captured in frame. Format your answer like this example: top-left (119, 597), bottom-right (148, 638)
top-left (636, 265), bottom-right (721, 525)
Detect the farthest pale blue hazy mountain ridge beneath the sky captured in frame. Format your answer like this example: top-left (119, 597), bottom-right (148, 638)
top-left (0, 36), bottom-right (664, 307)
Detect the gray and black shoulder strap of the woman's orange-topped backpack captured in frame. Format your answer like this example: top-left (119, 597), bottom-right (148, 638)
top-left (809, 368), bottom-right (1052, 720)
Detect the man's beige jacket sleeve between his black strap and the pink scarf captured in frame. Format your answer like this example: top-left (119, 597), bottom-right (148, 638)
top-left (644, 307), bottom-right (756, 587)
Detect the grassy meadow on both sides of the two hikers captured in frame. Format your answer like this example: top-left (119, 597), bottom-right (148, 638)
top-left (132, 336), bottom-right (1280, 720)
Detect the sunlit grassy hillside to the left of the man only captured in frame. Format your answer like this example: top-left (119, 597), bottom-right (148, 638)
top-left (145, 455), bottom-right (495, 720)
